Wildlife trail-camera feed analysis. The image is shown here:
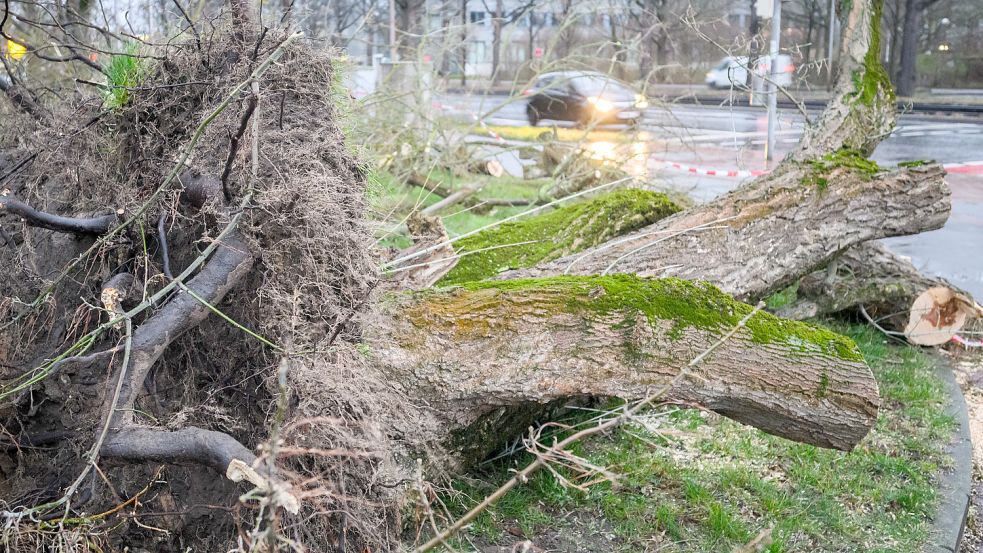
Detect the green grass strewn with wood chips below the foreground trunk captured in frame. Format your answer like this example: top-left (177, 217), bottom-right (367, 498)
top-left (436, 324), bottom-right (954, 553)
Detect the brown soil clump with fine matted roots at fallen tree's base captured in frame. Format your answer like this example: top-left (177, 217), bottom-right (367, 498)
top-left (0, 24), bottom-right (427, 551)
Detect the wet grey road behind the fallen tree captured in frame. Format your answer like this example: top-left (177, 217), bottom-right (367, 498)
top-left (435, 95), bottom-right (983, 299)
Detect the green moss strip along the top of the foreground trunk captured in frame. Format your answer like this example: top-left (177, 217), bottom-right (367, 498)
top-left (452, 275), bottom-right (863, 362)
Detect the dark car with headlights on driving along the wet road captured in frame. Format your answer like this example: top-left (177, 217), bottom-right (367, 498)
top-left (524, 71), bottom-right (648, 127)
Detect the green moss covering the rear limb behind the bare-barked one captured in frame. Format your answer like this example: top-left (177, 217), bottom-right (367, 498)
top-left (438, 189), bottom-right (680, 286)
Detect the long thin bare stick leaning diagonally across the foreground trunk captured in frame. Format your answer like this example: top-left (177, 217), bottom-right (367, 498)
top-left (413, 302), bottom-right (765, 553)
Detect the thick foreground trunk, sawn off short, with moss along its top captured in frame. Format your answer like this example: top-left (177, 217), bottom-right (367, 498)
top-left (367, 275), bottom-right (879, 465)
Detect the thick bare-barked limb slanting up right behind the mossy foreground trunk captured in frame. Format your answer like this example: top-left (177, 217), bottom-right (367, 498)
top-left (499, 162), bottom-right (951, 299)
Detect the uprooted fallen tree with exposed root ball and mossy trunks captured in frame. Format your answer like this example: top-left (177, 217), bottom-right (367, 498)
top-left (0, 1), bottom-right (948, 550)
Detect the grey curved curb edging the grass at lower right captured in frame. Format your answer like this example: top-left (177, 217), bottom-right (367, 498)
top-left (922, 355), bottom-right (973, 553)
